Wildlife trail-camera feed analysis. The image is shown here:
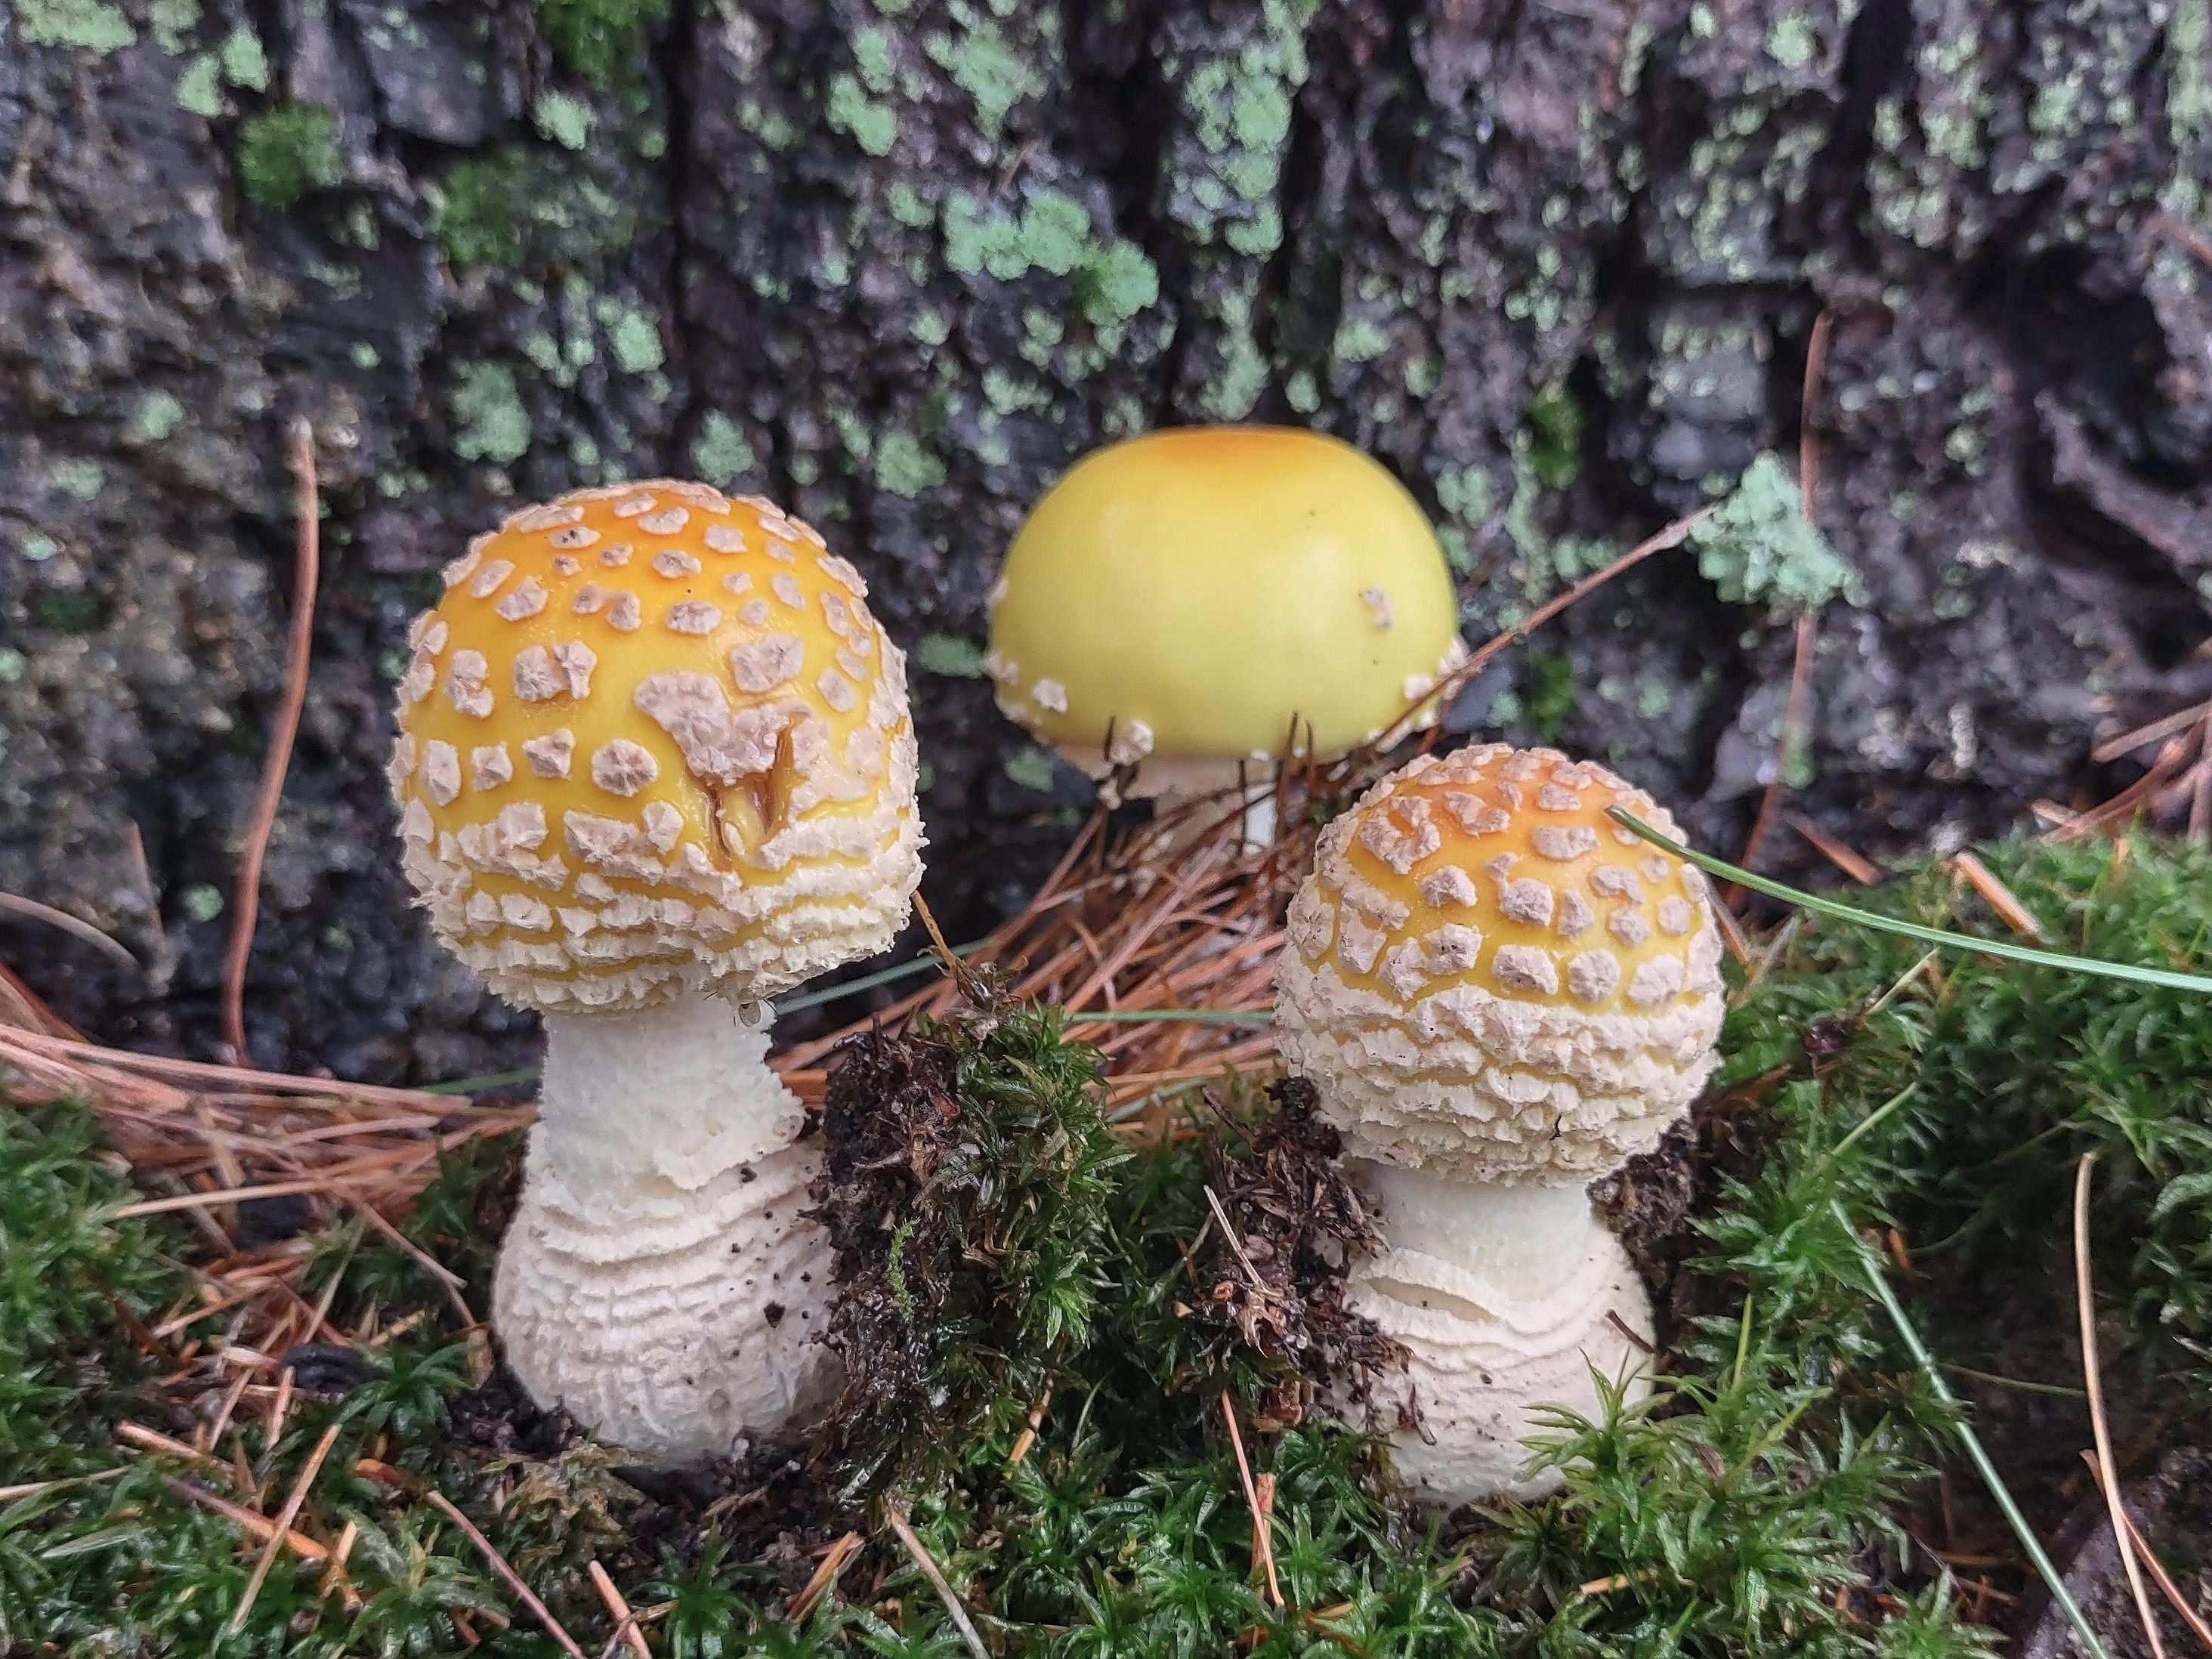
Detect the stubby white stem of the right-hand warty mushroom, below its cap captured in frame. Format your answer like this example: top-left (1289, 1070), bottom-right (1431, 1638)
top-left (1349, 1163), bottom-right (1652, 1506)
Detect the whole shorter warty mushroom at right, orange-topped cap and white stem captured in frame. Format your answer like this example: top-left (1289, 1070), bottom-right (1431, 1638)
top-left (1276, 743), bottom-right (1721, 1504)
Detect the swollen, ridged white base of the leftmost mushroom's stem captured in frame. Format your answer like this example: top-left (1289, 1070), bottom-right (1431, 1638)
top-left (493, 1144), bottom-right (839, 1462)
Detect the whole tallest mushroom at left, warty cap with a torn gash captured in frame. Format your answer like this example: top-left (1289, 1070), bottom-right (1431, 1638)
top-left (391, 480), bottom-right (922, 1460)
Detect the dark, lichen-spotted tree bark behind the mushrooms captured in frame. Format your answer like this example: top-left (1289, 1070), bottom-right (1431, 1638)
top-left (0, 0), bottom-right (2212, 1080)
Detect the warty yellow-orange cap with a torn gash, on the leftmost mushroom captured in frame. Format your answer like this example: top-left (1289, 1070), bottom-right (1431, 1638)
top-left (391, 480), bottom-right (922, 1013)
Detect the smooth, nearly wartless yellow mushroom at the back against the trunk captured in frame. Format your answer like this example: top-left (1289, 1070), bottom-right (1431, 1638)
top-left (984, 427), bottom-right (1466, 845)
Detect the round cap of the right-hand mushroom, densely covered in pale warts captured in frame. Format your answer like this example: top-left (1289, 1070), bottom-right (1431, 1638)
top-left (1276, 743), bottom-right (1721, 1182)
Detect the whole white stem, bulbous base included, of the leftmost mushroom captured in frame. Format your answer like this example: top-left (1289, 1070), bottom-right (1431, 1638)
top-left (493, 996), bottom-right (834, 1462)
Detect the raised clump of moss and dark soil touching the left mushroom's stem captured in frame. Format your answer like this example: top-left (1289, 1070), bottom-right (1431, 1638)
top-left (823, 1006), bottom-right (1126, 1484)
